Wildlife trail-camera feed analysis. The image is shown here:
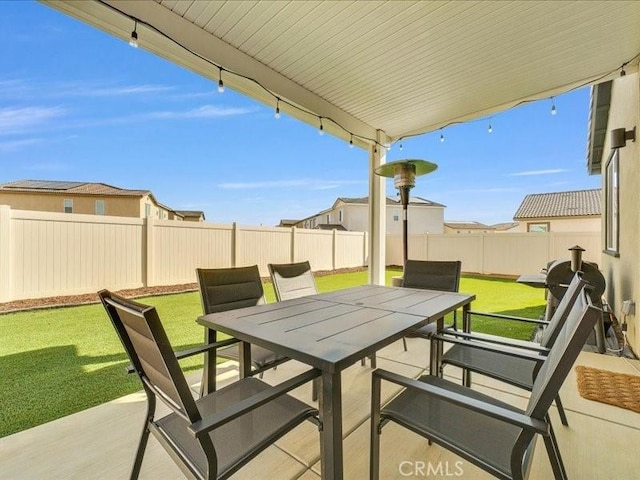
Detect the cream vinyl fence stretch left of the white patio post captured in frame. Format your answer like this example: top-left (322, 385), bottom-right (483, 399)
top-left (0, 206), bottom-right (368, 302)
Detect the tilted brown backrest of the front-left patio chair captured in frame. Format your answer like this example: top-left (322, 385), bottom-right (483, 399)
top-left (98, 290), bottom-right (201, 423)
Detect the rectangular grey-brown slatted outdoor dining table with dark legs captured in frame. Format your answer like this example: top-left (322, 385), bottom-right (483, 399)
top-left (198, 285), bottom-right (475, 479)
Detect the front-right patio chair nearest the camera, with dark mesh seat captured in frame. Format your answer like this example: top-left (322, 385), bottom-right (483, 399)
top-left (370, 288), bottom-right (602, 480)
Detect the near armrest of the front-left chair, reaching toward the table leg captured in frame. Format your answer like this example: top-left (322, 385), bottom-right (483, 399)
top-left (189, 368), bottom-right (320, 437)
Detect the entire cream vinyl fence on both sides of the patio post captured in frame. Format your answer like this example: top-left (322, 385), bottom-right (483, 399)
top-left (0, 206), bottom-right (601, 302)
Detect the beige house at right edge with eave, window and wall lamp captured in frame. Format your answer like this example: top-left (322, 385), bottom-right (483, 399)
top-left (587, 71), bottom-right (640, 353)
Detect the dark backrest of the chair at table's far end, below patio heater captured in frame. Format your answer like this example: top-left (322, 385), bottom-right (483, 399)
top-left (402, 260), bottom-right (462, 292)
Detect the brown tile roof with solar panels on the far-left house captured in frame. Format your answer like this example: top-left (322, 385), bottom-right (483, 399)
top-left (0, 180), bottom-right (151, 197)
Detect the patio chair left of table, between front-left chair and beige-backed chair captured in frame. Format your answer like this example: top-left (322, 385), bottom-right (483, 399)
top-left (196, 265), bottom-right (288, 392)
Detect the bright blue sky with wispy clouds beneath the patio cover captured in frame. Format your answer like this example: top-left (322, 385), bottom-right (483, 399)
top-left (0, 1), bottom-right (600, 225)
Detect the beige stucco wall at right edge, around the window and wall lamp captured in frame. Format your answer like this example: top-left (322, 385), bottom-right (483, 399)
top-left (601, 73), bottom-right (640, 354)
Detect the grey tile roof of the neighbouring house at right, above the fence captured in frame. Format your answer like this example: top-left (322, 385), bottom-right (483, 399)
top-left (513, 188), bottom-right (602, 220)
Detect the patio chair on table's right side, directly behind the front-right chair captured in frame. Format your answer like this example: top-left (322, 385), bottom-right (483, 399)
top-left (431, 273), bottom-right (587, 426)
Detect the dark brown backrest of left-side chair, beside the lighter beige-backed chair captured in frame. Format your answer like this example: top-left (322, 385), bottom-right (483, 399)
top-left (196, 265), bottom-right (264, 314)
